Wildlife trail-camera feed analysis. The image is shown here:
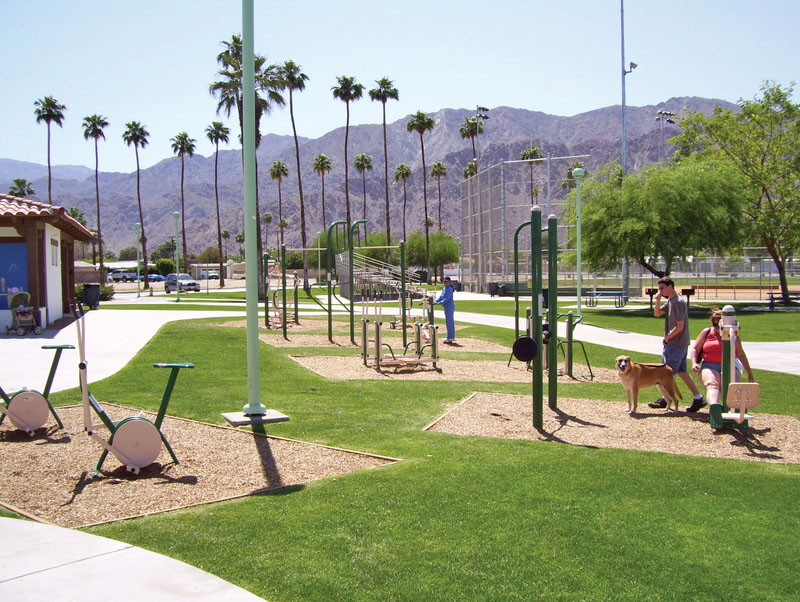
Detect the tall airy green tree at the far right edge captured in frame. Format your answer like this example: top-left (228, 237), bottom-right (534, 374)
top-left (672, 82), bottom-right (800, 301)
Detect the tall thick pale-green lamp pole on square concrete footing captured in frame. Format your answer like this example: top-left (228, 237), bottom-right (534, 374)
top-left (241, 0), bottom-right (267, 415)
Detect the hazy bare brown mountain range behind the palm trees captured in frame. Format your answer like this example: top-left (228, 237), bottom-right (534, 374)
top-left (0, 97), bottom-right (737, 253)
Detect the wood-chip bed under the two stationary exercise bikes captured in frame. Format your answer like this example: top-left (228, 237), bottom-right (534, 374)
top-left (0, 404), bottom-right (395, 527)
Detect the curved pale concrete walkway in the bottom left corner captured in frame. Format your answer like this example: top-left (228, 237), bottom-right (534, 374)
top-left (0, 518), bottom-right (262, 602)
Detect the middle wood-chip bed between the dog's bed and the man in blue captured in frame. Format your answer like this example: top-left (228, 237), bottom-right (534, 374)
top-left (292, 355), bottom-right (618, 383)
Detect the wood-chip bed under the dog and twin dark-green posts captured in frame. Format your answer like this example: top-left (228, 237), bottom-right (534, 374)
top-left (427, 393), bottom-right (800, 464)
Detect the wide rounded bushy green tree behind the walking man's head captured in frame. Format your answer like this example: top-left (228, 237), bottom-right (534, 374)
top-left (567, 161), bottom-right (746, 277)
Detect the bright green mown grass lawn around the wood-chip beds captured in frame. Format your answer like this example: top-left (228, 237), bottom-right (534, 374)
top-left (29, 314), bottom-right (800, 600)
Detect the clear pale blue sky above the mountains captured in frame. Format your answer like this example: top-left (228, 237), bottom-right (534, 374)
top-left (0, 0), bottom-right (800, 172)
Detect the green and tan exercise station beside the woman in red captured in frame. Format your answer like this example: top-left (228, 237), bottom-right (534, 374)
top-left (708, 305), bottom-right (761, 429)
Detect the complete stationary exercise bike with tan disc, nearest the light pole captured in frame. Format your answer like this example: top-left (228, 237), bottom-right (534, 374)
top-left (72, 305), bottom-right (194, 474)
